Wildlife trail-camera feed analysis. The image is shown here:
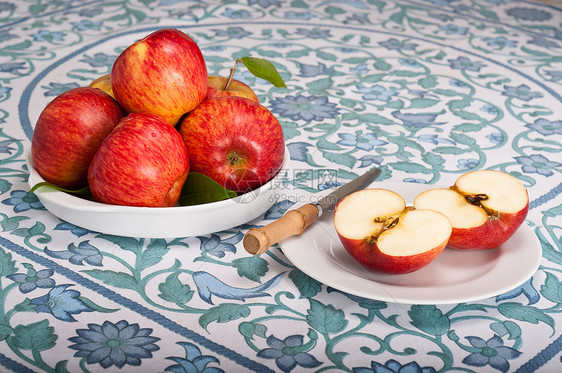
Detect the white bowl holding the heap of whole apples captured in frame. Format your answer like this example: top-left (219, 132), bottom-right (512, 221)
top-left (27, 150), bottom-right (289, 238)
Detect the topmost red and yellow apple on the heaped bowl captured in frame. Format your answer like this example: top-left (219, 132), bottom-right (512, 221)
top-left (111, 29), bottom-right (207, 125)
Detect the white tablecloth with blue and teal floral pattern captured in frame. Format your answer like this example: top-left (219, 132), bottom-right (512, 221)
top-left (0, 0), bottom-right (562, 373)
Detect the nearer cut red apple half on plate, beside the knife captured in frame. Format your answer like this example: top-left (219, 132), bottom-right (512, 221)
top-left (334, 189), bottom-right (452, 274)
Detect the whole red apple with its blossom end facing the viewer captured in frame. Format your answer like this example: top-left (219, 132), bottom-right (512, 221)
top-left (180, 96), bottom-right (285, 193)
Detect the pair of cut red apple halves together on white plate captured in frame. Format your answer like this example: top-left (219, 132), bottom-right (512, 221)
top-left (334, 170), bottom-right (529, 274)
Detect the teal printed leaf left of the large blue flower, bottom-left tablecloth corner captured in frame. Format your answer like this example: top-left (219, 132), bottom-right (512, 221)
top-left (12, 320), bottom-right (58, 351)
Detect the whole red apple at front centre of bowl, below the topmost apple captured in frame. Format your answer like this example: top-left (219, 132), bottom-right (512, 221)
top-left (88, 113), bottom-right (189, 207)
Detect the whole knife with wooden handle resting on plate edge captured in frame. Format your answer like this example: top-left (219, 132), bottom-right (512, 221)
top-left (243, 168), bottom-right (381, 255)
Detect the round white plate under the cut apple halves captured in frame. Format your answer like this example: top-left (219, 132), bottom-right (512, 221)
top-left (280, 182), bottom-right (542, 304)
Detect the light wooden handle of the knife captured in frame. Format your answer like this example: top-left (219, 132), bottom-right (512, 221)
top-left (243, 203), bottom-right (318, 255)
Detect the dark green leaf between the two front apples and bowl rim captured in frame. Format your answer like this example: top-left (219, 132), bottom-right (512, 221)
top-left (179, 172), bottom-right (237, 206)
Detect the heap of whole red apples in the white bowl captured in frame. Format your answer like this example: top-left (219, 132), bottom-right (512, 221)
top-left (31, 29), bottom-right (285, 207)
